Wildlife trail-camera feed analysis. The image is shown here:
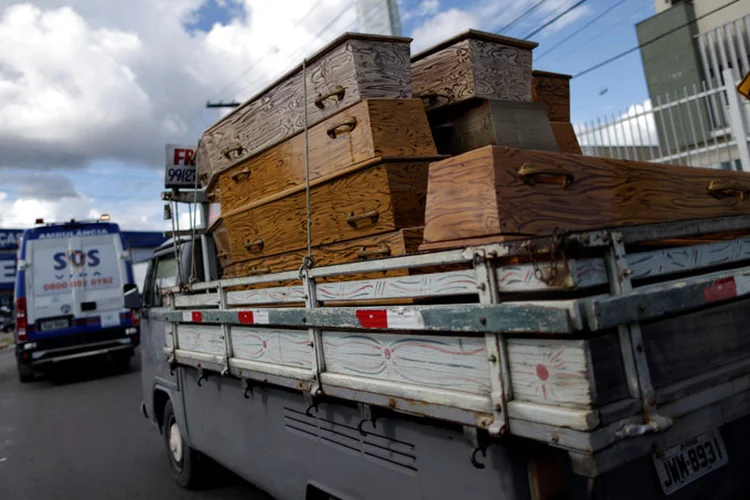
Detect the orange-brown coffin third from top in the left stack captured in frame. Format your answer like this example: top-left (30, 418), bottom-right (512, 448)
top-left (224, 159), bottom-right (438, 261)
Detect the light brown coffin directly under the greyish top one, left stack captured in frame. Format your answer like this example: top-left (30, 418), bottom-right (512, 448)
top-left (220, 99), bottom-right (436, 213)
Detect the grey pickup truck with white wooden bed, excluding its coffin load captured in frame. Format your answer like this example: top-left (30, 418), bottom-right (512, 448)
top-left (142, 195), bottom-right (750, 500)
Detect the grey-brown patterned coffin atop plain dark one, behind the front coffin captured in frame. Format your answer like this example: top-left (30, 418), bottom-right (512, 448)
top-left (412, 30), bottom-right (558, 155)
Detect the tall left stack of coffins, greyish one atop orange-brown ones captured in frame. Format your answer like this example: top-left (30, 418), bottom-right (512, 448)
top-left (198, 34), bottom-right (440, 277)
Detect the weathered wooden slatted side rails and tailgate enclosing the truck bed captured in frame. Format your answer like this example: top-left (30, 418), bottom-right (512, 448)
top-left (148, 217), bottom-right (750, 477)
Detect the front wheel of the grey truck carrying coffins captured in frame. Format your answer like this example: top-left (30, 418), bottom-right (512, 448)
top-left (162, 401), bottom-right (204, 490)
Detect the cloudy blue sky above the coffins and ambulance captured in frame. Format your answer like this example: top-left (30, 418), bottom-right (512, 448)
top-left (0, 0), bottom-right (654, 229)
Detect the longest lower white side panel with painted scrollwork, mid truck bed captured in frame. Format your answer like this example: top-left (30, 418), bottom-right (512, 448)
top-left (323, 331), bottom-right (490, 394)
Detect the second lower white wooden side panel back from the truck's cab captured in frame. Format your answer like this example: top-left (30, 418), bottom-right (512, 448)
top-left (230, 326), bottom-right (313, 368)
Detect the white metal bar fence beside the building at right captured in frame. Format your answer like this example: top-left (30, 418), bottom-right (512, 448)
top-left (575, 69), bottom-right (750, 171)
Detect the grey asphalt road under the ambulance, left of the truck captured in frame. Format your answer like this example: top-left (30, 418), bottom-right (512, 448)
top-left (0, 348), bottom-right (268, 500)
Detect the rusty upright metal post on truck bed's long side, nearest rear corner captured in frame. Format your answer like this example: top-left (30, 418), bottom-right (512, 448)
top-left (474, 250), bottom-right (513, 436)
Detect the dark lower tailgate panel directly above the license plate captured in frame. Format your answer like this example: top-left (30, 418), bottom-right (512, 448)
top-left (642, 300), bottom-right (750, 388)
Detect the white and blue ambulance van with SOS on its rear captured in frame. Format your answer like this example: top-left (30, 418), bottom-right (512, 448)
top-left (14, 220), bottom-right (140, 382)
